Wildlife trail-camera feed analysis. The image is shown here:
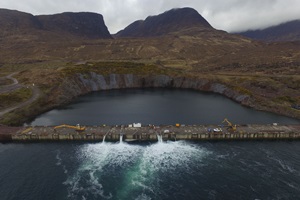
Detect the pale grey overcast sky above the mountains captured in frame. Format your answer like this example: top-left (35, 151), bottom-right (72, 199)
top-left (0, 0), bottom-right (300, 33)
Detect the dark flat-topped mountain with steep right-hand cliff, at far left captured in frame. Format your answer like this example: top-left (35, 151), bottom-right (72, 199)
top-left (0, 9), bottom-right (112, 39)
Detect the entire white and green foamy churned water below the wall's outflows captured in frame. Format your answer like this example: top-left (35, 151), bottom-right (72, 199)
top-left (64, 138), bottom-right (209, 199)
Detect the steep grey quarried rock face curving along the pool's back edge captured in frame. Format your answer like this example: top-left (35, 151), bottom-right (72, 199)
top-left (59, 72), bottom-right (250, 105)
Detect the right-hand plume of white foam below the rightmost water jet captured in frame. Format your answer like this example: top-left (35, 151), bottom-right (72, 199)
top-left (125, 141), bottom-right (209, 199)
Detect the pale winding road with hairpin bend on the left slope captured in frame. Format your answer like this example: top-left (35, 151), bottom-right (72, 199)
top-left (0, 72), bottom-right (41, 118)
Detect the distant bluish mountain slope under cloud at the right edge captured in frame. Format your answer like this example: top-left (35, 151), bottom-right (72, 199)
top-left (238, 20), bottom-right (300, 42)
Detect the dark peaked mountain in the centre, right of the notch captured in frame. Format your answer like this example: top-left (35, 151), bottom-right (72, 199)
top-left (115, 8), bottom-right (213, 37)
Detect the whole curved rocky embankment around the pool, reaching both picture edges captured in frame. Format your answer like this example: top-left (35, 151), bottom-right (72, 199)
top-left (1, 71), bottom-right (299, 125)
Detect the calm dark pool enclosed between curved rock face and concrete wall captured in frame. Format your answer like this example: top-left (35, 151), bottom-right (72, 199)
top-left (31, 89), bottom-right (300, 125)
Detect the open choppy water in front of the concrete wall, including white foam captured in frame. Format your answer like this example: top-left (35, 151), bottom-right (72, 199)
top-left (0, 141), bottom-right (300, 200)
